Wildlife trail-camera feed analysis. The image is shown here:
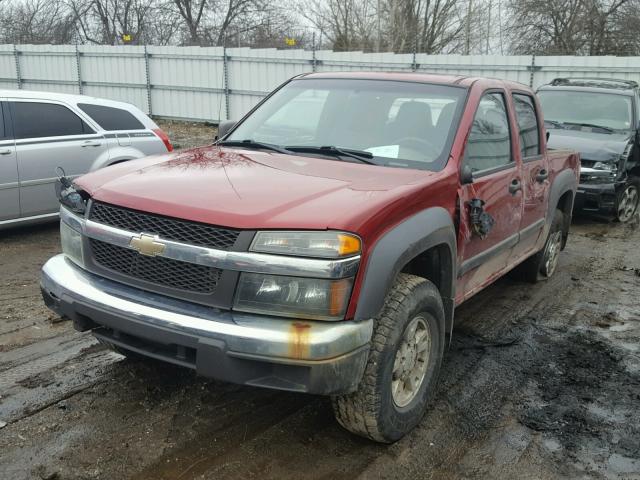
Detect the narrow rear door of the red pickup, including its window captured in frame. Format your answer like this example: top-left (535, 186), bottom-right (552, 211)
top-left (512, 91), bottom-right (549, 262)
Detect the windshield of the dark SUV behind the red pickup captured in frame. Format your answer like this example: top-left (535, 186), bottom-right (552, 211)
top-left (538, 90), bottom-right (633, 133)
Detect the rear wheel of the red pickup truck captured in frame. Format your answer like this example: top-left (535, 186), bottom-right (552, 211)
top-left (513, 209), bottom-right (564, 283)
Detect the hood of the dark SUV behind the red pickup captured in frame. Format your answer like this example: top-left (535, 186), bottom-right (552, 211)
top-left (548, 129), bottom-right (632, 162)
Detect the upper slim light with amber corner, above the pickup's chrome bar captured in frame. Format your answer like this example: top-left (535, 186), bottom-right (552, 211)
top-left (250, 231), bottom-right (361, 258)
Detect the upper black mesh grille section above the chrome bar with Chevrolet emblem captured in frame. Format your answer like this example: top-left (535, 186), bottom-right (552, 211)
top-left (89, 202), bottom-right (240, 250)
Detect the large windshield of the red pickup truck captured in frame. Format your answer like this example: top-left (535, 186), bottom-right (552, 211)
top-left (225, 79), bottom-right (466, 171)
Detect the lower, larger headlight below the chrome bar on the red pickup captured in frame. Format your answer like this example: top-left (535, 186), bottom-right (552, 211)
top-left (234, 273), bottom-right (353, 320)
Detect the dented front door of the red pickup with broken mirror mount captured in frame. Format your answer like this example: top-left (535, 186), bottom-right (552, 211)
top-left (457, 91), bottom-right (523, 301)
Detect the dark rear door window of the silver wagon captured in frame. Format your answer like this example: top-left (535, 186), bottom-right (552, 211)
top-left (9, 101), bottom-right (95, 140)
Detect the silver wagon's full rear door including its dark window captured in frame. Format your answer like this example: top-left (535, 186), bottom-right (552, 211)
top-left (9, 100), bottom-right (109, 217)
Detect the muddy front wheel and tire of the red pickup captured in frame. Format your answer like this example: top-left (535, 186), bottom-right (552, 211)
top-left (332, 273), bottom-right (444, 443)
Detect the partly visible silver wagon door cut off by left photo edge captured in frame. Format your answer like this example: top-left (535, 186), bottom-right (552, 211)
top-left (0, 99), bottom-right (20, 222)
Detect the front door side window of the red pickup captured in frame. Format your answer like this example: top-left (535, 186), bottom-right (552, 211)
top-left (465, 93), bottom-right (513, 172)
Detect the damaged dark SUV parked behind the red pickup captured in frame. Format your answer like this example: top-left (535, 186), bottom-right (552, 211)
top-left (538, 78), bottom-right (640, 222)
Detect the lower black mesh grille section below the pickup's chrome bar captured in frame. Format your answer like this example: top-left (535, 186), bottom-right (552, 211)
top-left (89, 238), bottom-right (222, 294)
